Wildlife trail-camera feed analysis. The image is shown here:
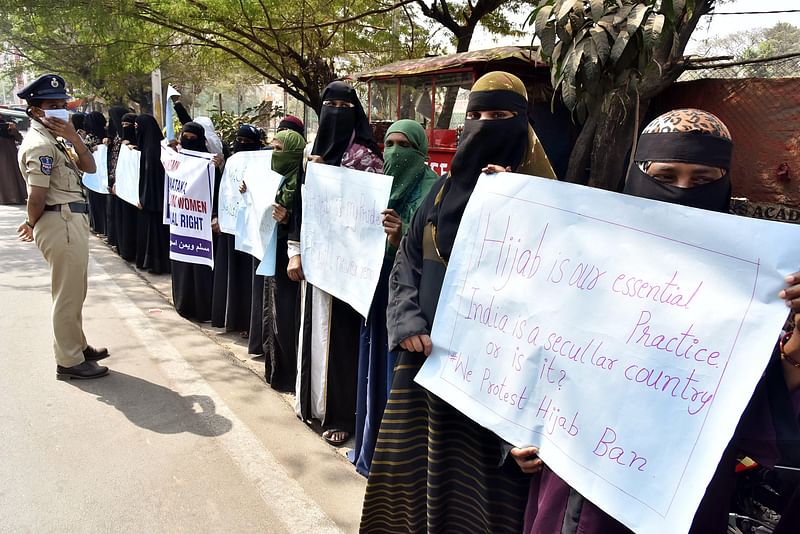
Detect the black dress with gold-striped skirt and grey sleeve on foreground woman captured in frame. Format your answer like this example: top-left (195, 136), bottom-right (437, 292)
top-left (361, 197), bottom-right (529, 534)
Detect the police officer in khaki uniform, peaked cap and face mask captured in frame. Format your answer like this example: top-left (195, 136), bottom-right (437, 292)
top-left (17, 74), bottom-right (108, 380)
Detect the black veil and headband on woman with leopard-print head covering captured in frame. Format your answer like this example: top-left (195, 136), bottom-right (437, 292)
top-left (624, 131), bottom-right (733, 213)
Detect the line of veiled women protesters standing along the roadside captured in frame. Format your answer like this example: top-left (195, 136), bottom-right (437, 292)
top-left (7, 72), bottom-right (800, 534)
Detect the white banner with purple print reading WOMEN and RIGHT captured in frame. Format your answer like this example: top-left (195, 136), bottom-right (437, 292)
top-left (161, 145), bottom-right (214, 268)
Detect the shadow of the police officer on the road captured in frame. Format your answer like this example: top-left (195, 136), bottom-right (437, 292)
top-left (64, 371), bottom-right (233, 437)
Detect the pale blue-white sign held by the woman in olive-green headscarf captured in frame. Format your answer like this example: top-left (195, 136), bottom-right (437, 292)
top-left (235, 169), bottom-right (283, 276)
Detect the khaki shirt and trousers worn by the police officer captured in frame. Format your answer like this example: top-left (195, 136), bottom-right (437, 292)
top-left (19, 121), bottom-right (89, 367)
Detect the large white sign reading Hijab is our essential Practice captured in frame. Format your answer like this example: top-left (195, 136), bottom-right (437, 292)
top-left (416, 173), bottom-right (800, 533)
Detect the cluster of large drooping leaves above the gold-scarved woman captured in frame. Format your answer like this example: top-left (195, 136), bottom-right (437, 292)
top-left (528, 0), bottom-right (695, 122)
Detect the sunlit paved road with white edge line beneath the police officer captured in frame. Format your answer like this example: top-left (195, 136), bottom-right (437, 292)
top-left (0, 206), bottom-right (365, 533)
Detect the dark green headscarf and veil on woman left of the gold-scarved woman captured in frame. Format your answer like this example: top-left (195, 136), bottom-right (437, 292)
top-left (383, 119), bottom-right (439, 256)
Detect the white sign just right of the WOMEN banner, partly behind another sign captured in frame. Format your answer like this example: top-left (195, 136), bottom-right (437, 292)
top-left (217, 150), bottom-right (272, 234)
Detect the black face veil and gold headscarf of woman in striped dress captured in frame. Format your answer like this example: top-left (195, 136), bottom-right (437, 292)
top-left (429, 72), bottom-right (529, 259)
